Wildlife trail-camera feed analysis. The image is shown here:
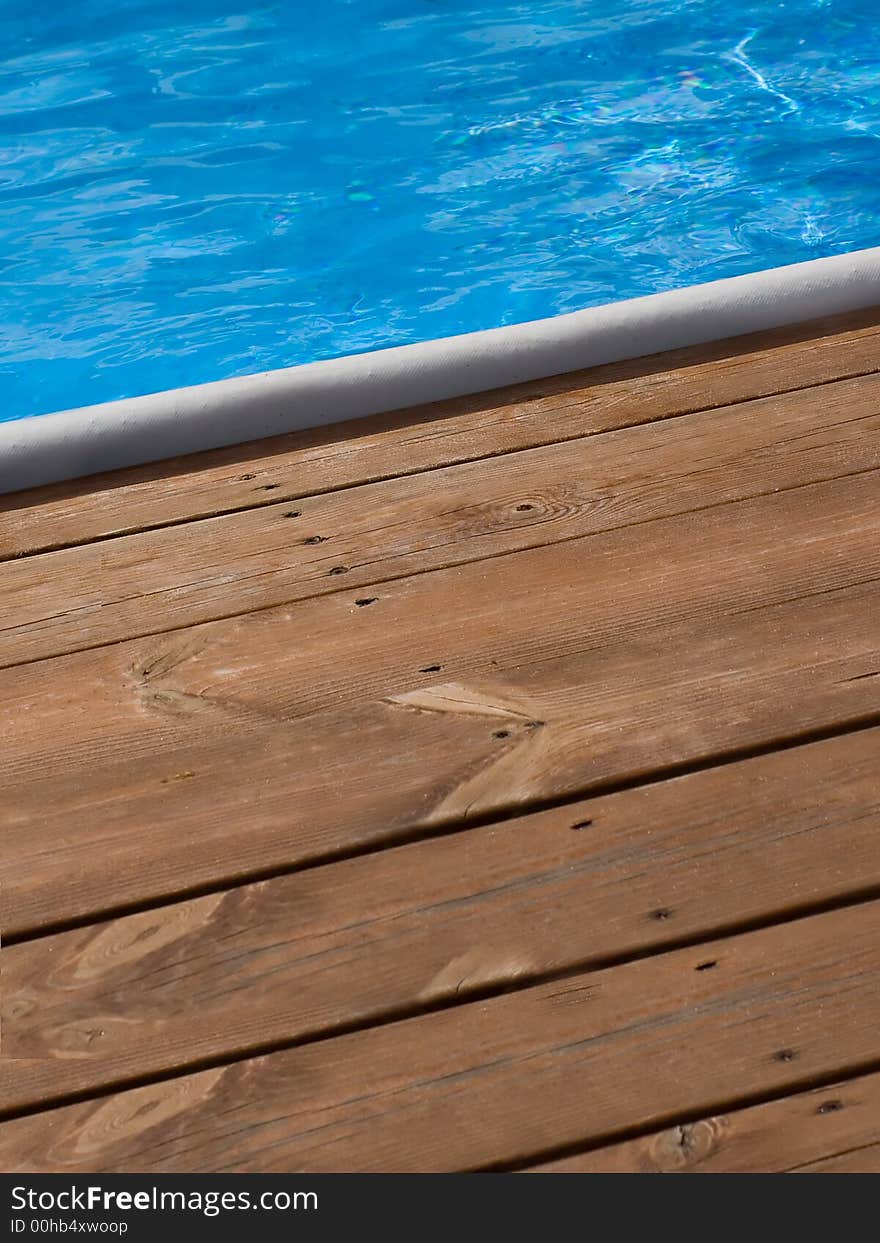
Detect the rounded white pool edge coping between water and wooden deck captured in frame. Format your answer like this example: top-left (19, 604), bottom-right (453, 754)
top-left (0, 246), bottom-right (880, 493)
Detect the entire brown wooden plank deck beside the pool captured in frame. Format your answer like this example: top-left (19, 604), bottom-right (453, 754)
top-left (0, 310), bottom-right (880, 1173)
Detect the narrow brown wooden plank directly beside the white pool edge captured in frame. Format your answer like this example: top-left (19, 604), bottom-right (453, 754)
top-left (0, 308), bottom-right (880, 557)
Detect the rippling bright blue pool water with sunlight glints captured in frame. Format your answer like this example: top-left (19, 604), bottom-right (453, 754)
top-left (0, 0), bottom-right (880, 420)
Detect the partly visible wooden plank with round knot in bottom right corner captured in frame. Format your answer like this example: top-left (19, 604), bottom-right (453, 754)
top-left (529, 1075), bottom-right (880, 1173)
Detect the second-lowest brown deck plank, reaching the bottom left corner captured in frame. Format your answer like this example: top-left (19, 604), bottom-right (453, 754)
top-left (0, 904), bottom-right (880, 1173)
